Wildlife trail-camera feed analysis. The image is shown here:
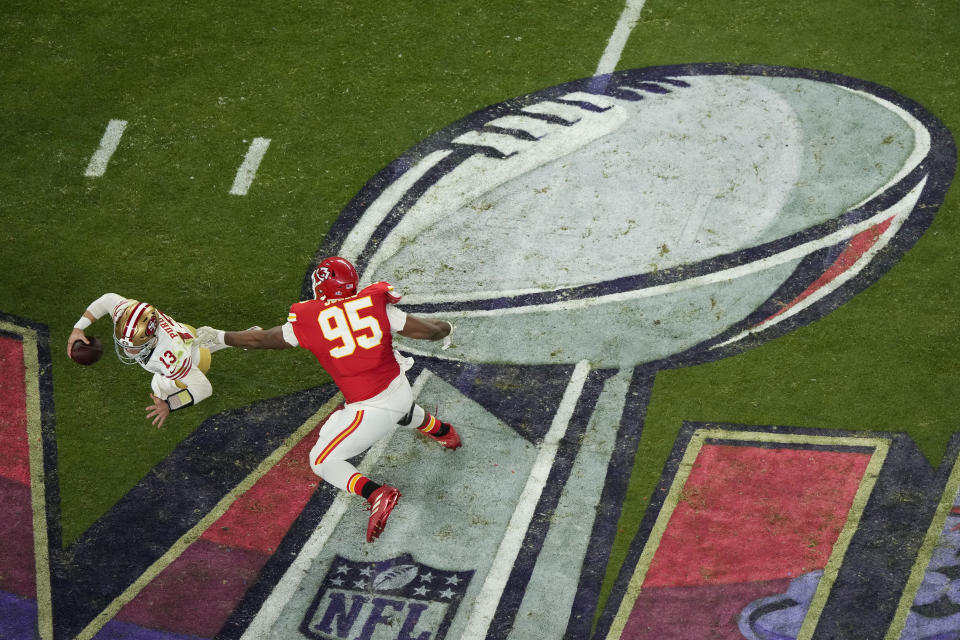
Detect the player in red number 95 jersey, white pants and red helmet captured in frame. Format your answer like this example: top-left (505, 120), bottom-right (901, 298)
top-left (198, 256), bottom-right (461, 542)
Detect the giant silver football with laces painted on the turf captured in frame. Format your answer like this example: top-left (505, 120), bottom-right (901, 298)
top-left (319, 64), bottom-right (956, 368)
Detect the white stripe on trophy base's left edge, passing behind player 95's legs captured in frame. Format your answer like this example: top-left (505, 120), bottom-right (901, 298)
top-left (241, 371), bottom-right (433, 640)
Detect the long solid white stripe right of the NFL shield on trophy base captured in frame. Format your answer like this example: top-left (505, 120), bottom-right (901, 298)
top-left (461, 360), bottom-right (590, 640)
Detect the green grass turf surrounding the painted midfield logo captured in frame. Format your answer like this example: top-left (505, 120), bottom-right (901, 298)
top-left (0, 0), bottom-right (960, 632)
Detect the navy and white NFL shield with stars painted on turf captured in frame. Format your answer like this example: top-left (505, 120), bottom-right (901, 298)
top-left (300, 554), bottom-right (474, 640)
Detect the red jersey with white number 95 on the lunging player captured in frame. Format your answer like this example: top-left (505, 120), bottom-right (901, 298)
top-left (287, 282), bottom-right (400, 402)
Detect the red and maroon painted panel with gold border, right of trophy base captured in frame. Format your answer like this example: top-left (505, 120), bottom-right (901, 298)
top-left (622, 444), bottom-right (870, 640)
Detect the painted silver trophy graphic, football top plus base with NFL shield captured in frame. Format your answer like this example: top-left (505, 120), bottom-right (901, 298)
top-left (242, 64), bottom-right (955, 639)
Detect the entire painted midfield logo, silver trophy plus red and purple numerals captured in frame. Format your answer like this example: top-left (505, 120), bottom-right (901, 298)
top-left (0, 64), bottom-right (960, 640)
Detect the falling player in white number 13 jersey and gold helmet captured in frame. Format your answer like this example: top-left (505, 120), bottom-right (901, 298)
top-left (67, 293), bottom-right (231, 429)
